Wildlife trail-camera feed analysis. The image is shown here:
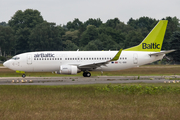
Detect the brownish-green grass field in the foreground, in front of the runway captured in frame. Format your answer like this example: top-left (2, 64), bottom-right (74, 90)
top-left (0, 84), bottom-right (180, 120)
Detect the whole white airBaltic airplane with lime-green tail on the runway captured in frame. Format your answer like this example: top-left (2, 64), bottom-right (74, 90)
top-left (3, 20), bottom-right (175, 77)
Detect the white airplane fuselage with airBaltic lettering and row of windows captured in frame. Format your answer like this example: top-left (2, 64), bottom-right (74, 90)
top-left (5, 51), bottom-right (164, 72)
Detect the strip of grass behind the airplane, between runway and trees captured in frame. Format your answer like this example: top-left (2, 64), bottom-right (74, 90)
top-left (0, 65), bottom-right (180, 77)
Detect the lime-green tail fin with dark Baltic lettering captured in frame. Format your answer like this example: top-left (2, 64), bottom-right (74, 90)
top-left (124, 20), bottom-right (168, 52)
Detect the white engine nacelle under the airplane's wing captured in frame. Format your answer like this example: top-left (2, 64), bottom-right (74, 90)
top-left (57, 65), bottom-right (79, 75)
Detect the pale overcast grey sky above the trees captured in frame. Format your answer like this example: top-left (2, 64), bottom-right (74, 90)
top-left (0, 0), bottom-right (180, 25)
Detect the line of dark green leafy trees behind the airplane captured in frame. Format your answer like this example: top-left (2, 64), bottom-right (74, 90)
top-left (0, 9), bottom-right (180, 61)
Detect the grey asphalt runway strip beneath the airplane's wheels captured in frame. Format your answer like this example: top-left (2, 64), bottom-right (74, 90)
top-left (0, 75), bottom-right (180, 85)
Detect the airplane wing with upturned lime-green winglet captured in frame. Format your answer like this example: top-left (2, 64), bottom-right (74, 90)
top-left (78, 49), bottom-right (122, 70)
